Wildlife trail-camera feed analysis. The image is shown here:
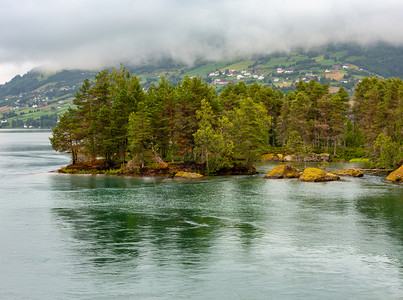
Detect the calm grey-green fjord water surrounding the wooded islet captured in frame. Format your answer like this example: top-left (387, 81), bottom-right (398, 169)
top-left (0, 130), bottom-right (403, 299)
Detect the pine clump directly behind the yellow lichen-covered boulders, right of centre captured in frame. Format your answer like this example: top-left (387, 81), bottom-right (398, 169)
top-left (277, 80), bottom-right (349, 154)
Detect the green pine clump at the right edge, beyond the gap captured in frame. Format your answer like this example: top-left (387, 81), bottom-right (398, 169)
top-left (353, 78), bottom-right (403, 167)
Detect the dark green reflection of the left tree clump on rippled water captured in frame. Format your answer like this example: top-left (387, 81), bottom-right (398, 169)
top-left (52, 176), bottom-right (263, 265)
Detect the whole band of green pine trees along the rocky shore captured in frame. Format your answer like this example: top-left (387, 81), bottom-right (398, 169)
top-left (50, 67), bottom-right (403, 174)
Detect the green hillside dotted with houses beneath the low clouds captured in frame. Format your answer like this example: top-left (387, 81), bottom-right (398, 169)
top-left (0, 44), bottom-right (403, 128)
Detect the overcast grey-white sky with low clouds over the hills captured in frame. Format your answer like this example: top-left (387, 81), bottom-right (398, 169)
top-left (0, 0), bottom-right (403, 83)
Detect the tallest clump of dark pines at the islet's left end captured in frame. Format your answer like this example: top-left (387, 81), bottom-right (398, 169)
top-left (54, 67), bottom-right (143, 165)
